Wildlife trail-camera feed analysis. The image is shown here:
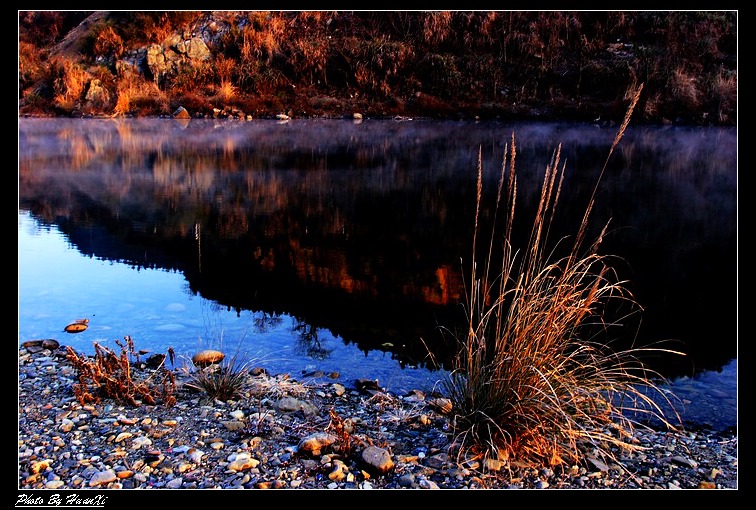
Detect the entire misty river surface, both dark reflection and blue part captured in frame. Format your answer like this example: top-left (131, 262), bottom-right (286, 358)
top-left (18, 119), bottom-right (737, 430)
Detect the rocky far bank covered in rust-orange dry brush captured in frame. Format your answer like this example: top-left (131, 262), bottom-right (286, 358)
top-left (19, 11), bottom-right (737, 125)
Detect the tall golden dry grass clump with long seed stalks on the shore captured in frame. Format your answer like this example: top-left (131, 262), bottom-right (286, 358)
top-left (444, 85), bottom-right (674, 466)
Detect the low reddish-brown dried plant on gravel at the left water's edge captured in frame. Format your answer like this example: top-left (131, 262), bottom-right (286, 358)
top-left (66, 336), bottom-right (176, 407)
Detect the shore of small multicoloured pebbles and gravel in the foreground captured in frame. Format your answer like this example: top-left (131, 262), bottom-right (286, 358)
top-left (17, 344), bottom-right (738, 490)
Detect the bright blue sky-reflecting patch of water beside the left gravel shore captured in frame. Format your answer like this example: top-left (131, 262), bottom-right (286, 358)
top-left (18, 212), bottom-right (443, 393)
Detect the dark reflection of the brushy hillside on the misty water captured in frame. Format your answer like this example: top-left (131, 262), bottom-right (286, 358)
top-left (19, 119), bottom-right (736, 374)
